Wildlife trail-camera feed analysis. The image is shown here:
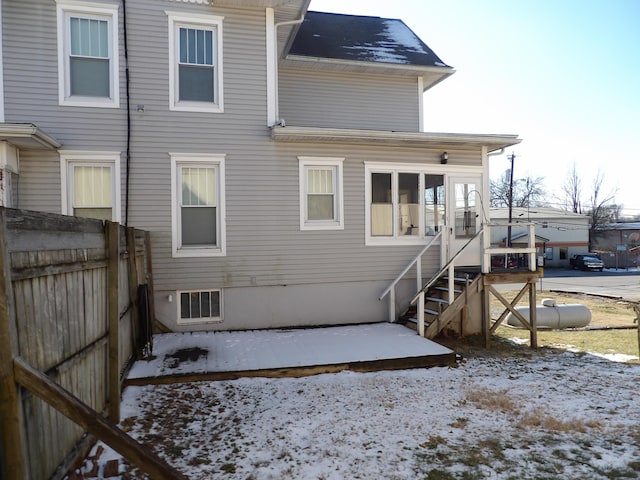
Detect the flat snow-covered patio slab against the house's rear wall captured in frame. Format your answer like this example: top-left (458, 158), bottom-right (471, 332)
top-left (128, 323), bottom-right (453, 379)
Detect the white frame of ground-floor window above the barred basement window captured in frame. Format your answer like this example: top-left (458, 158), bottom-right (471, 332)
top-left (169, 153), bottom-right (227, 258)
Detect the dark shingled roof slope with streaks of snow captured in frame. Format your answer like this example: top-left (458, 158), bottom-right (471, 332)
top-left (289, 12), bottom-right (448, 67)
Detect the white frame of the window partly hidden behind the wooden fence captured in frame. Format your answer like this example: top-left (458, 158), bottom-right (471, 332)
top-left (59, 150), bottom-right (121, 222)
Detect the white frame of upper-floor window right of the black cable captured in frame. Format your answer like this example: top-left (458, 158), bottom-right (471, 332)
top-left (165, 11), bottom-right (224, 113)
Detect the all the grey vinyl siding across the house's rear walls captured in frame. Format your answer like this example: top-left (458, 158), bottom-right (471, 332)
top-left (3, 0), bottom-right (490, 328)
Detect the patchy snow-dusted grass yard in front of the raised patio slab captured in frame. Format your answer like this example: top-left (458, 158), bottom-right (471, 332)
top-left (71, 342), bottom-right (640, 480)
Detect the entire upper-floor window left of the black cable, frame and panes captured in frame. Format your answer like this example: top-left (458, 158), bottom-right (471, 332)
top-left (57, 0), bottom-right (120, 108)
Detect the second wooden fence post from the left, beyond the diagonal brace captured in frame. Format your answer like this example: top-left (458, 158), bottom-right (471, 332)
top-left (105, 222), bottom-right (120, 423)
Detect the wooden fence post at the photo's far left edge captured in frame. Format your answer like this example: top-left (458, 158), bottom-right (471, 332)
top-left (0, 208), bottom-right (27, 480)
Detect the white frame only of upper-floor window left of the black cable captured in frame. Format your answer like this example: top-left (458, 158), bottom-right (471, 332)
top-left (56, 0), bottom-right (120, 108)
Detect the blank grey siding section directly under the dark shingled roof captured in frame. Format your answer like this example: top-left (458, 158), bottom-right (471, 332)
top-left (279, 68), bottom-right (419, 132)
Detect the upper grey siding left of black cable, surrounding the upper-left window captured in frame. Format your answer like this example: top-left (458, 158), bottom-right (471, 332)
top-left (2, 0), bottom-right (126, 151)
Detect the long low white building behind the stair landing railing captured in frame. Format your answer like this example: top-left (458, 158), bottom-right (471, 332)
top-left (491, 208), bottom-right (589, 268)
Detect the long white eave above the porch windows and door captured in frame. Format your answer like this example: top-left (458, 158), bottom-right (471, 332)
top-left (271, 126), bottom-right (521, 151)
